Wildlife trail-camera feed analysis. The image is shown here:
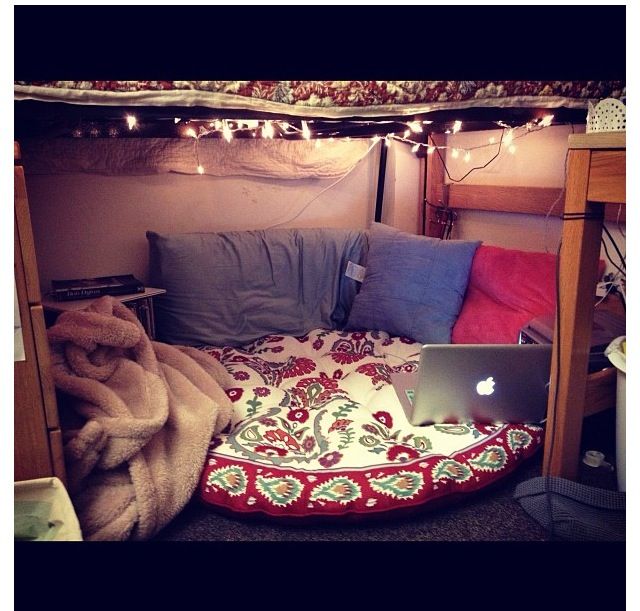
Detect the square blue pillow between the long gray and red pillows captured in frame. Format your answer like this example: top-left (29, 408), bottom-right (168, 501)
top-left (347, 223), bottom-right (481, 344)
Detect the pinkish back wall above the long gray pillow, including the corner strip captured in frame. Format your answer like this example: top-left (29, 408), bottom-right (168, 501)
top-left (27, 143), bottom-right (420, 292)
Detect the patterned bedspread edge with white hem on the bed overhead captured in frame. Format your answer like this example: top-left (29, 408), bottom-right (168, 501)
top-left (15, 80), bottom-right (626, 117)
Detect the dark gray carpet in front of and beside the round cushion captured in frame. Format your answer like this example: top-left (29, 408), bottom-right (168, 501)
top-left (155, 410), bottom-right (616, 542)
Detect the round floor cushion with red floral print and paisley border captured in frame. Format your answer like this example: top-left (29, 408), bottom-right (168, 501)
top-left (199, 329), bottom-right (543, 518)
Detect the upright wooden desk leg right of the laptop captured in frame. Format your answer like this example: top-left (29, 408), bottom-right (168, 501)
top-left (542, 150), bottom-right (604, 479)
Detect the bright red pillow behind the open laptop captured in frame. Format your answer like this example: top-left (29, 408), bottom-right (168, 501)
top-left (451, 245), bottom-right (556, 344)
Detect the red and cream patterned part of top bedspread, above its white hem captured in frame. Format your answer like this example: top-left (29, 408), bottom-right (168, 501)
top-left (15, 80), bottom-right (626, 114)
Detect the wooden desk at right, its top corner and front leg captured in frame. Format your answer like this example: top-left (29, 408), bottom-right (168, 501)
top-left (542, 132), bottom-right (626, 479)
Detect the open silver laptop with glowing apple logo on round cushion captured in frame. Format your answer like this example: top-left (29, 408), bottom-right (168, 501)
top-left (391, 344), bottom-right (551, 426)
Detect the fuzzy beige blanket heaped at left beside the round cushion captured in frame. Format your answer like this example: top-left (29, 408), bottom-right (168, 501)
top-left (48, 296), bottom-right (233, 541)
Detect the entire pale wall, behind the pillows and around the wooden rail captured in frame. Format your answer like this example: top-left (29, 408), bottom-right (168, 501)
top-left (27, 126), bottom-right (625, 292)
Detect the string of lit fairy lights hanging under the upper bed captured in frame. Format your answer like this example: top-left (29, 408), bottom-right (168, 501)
top-left (114, 114), bottom-right (553, 174)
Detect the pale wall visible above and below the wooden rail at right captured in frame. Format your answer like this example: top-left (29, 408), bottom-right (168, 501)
top-left (445, 125), bottom-right (625, 271)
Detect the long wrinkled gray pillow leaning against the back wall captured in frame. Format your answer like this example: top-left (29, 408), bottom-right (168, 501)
top-left (147, 228), bottom-right (367, 346)
